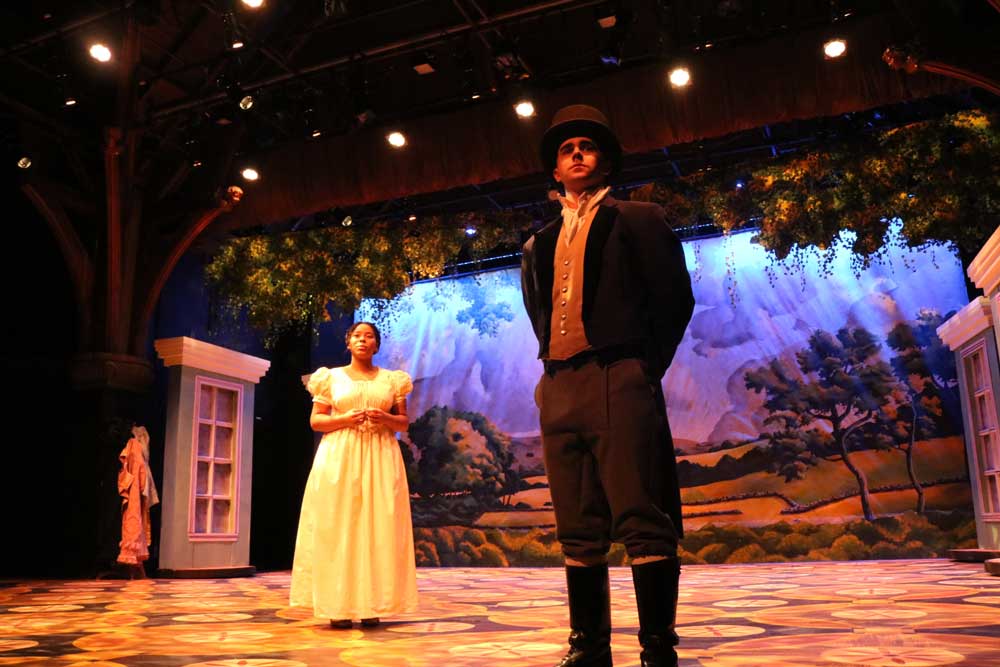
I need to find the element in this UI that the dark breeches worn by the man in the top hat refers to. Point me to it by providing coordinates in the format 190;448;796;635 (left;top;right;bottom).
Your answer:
536;358;678;558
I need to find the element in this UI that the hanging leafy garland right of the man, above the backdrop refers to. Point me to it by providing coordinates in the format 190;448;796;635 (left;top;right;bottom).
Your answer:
644;111;1000;264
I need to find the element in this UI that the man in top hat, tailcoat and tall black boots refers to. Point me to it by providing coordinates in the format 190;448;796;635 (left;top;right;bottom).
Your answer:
521;105;694;667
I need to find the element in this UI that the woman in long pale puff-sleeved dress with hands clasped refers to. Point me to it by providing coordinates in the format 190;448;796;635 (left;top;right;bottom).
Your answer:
291;322;417;628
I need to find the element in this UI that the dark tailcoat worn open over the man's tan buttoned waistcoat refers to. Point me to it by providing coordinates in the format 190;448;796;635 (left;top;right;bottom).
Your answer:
521;197;694;379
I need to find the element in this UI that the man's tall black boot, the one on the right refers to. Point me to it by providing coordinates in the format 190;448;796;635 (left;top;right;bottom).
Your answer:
632;558;681;667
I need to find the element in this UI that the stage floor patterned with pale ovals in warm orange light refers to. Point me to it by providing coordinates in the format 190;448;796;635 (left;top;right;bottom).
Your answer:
0;560;1000;667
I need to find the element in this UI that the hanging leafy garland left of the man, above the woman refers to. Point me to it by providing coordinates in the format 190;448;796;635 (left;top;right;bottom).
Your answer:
206;212;532;343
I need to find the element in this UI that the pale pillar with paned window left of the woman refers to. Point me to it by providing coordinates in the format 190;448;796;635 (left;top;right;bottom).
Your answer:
154;336;271;577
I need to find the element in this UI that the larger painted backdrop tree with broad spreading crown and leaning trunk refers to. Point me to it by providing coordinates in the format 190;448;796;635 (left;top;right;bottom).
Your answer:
744;327;896;521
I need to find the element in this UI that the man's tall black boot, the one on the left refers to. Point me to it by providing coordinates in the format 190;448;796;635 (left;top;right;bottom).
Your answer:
556;565;611;667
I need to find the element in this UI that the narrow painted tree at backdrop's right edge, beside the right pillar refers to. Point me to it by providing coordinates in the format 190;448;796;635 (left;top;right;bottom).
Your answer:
883;310;961;513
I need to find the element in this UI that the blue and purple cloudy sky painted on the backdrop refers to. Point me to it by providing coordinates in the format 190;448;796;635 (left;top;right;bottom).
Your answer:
358;226;968;442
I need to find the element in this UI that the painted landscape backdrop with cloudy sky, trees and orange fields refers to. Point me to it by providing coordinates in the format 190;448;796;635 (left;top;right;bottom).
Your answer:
358;223;975;565
